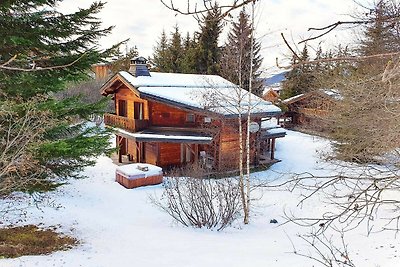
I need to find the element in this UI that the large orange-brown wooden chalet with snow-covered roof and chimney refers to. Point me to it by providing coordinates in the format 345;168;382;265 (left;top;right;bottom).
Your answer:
101;57;285;170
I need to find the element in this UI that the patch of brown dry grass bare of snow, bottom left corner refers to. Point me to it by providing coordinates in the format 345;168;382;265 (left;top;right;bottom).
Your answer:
0;225;78;258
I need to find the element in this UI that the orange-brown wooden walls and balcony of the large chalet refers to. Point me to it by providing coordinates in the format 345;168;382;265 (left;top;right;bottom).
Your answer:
105;81;268;170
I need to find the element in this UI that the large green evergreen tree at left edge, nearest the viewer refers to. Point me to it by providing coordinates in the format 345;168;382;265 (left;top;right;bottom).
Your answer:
0;0;116;194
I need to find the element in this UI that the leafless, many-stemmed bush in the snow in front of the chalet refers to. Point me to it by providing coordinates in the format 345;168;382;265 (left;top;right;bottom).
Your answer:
153;165;240;231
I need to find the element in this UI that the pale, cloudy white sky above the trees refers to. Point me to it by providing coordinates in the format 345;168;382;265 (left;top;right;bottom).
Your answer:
59;0;367;76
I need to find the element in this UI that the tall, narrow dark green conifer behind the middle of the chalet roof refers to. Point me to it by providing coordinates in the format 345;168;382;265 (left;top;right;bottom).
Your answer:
196;5;222;74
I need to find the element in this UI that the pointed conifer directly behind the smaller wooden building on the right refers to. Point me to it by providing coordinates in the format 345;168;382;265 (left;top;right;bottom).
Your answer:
281;45;317;99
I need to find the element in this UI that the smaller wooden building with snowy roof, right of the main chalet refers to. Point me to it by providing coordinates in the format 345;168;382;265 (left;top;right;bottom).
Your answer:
282;89;340;131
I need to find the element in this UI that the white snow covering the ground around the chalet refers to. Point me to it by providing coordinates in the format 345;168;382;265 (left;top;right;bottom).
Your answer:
0;131;400;267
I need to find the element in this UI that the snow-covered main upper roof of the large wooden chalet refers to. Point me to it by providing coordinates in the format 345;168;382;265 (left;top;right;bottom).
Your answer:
109;71;281;116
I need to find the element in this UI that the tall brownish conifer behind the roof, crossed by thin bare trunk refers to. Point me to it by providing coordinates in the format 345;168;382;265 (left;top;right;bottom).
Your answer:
220;10;263;96
